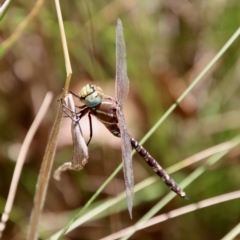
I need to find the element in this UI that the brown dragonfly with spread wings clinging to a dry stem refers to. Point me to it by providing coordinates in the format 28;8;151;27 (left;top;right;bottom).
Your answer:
68;19;187;218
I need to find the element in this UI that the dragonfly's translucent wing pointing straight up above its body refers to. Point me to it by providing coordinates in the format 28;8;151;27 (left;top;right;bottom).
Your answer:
115;19;129;106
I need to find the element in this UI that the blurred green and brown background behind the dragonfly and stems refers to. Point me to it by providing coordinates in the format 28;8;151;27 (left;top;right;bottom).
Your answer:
0;0;240;240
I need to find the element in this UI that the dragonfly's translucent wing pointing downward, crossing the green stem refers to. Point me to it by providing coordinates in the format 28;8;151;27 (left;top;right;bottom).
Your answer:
117;108;134;218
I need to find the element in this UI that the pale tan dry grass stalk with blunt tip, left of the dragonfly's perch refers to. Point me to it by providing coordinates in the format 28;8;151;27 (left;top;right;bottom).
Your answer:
0;92;53;238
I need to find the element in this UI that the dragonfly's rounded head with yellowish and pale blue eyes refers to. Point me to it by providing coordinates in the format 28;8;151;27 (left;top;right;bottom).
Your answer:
79;84;104;107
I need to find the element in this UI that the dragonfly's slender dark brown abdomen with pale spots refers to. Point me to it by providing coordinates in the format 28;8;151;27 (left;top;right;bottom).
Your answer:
130;137;187;198
